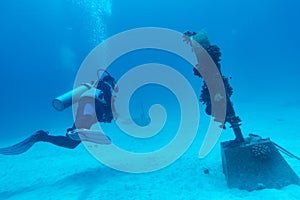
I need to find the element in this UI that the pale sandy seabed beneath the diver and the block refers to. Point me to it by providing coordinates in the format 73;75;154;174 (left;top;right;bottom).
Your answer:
0;101;300;200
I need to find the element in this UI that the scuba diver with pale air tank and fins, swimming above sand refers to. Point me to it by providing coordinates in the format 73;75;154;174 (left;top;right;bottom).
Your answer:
0;69;118;155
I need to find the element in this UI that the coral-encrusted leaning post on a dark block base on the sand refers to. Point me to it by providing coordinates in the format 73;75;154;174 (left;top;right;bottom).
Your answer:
184;31;300;191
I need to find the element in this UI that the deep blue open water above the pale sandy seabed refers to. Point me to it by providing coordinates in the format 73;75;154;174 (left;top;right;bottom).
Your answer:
0;0;300;141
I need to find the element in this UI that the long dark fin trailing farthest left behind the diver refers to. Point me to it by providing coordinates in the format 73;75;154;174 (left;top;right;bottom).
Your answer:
0;130;49;155
